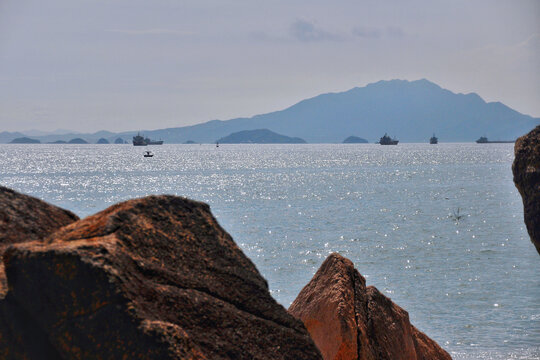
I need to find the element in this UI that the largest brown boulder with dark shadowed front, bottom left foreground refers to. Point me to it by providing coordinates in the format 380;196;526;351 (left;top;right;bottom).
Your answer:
0;196;321;359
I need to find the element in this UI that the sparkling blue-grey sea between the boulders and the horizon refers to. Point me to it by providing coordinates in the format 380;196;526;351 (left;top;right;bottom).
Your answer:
0;143;540;359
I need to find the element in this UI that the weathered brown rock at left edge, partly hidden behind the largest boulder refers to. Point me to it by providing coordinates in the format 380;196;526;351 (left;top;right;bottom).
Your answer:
0;186;79;298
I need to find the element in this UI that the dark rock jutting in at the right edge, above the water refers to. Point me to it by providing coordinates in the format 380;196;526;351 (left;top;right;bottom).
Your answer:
512;126;540;254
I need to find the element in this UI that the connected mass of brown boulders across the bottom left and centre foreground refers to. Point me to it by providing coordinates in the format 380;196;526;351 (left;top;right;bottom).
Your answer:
0;188;450;360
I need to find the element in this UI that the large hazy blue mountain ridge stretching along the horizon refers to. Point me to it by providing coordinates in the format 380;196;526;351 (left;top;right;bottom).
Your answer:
4;79;540;144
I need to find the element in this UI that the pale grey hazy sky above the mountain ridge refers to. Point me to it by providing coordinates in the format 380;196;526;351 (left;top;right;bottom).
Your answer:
0;0;540;132
